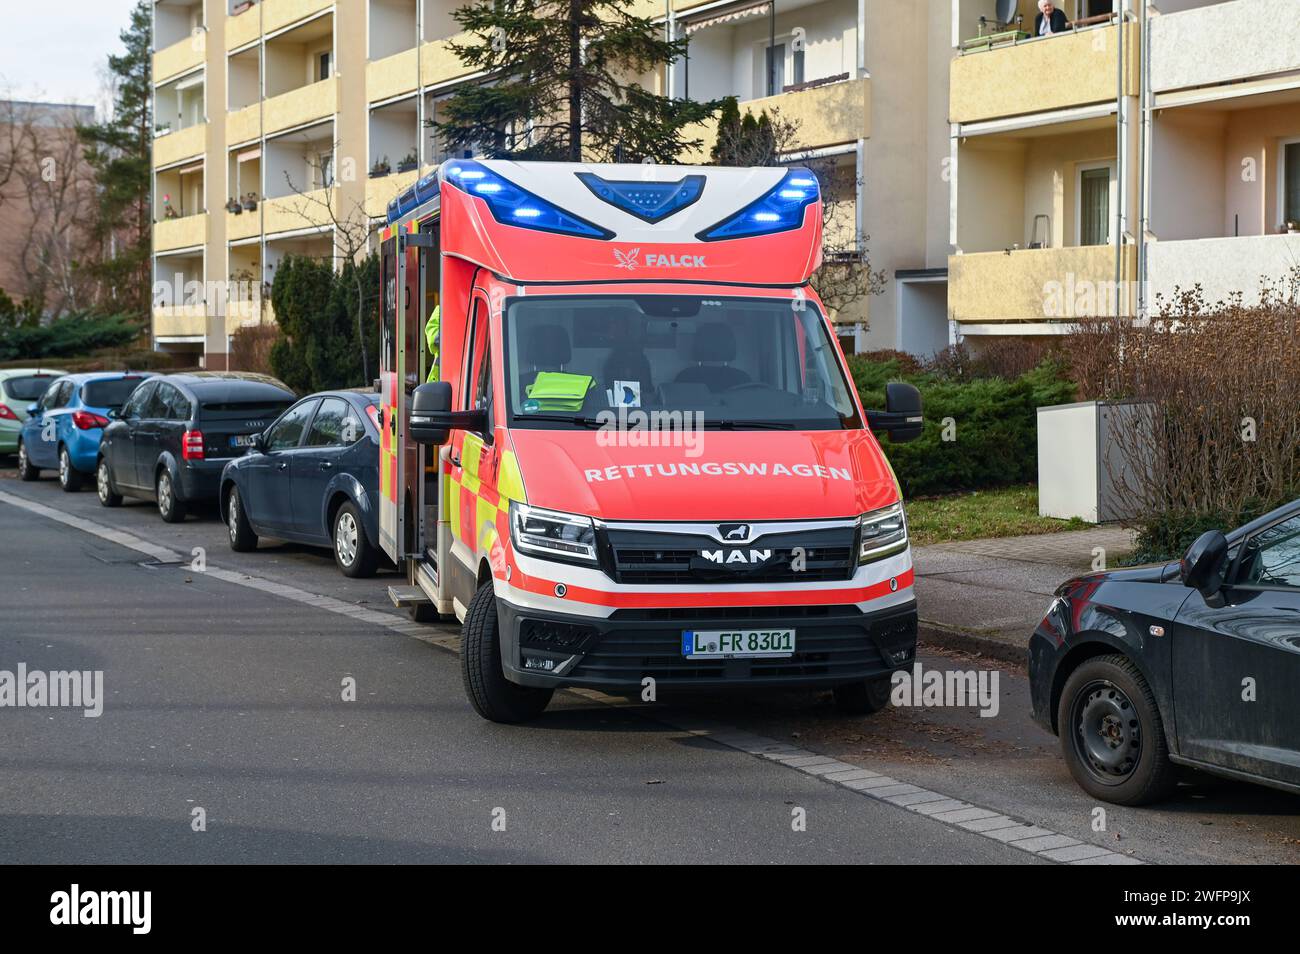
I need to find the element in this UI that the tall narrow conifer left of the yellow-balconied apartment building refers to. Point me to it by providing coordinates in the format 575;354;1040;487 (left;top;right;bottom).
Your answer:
77;0;153;316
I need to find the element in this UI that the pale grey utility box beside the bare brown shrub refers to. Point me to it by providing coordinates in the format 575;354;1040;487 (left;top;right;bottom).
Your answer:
1037;400;1152;524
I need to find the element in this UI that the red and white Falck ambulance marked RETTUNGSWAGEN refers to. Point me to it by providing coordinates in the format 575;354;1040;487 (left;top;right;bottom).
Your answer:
380;159;922;723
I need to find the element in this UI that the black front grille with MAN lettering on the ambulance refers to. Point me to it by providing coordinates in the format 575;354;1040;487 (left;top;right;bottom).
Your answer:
606;526;855;585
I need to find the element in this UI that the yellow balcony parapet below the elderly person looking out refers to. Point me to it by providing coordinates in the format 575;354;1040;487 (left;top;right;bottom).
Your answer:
948;23;1138;122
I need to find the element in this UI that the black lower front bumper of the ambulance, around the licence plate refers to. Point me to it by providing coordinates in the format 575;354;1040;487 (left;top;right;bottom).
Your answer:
497;597;917;691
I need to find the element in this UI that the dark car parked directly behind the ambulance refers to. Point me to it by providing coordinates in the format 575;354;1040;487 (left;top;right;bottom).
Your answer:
220;391;380;577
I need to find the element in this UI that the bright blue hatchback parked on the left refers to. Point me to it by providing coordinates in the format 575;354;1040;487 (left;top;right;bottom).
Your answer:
18;372;153;493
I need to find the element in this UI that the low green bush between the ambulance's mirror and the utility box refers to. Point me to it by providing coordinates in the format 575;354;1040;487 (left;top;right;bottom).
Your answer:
849;355;1074;496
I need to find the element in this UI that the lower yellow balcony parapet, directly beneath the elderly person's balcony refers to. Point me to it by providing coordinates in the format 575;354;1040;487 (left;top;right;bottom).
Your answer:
948;246;1138;324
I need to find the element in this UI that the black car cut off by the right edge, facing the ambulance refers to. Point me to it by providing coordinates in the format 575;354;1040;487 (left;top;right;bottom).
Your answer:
1030;500;1300;805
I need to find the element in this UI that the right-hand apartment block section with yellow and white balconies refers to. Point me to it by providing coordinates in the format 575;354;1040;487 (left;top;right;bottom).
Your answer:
949;0;1300;346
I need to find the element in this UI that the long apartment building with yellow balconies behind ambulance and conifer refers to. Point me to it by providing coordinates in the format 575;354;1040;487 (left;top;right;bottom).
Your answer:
153;0;952;368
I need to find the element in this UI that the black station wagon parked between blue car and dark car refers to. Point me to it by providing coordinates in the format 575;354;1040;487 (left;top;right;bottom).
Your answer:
95;372;295;524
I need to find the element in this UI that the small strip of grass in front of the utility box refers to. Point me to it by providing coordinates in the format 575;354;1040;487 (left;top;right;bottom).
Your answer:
905;483;1091;546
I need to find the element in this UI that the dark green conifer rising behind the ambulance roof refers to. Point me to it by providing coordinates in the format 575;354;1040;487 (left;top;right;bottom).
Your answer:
430;0;720;162
